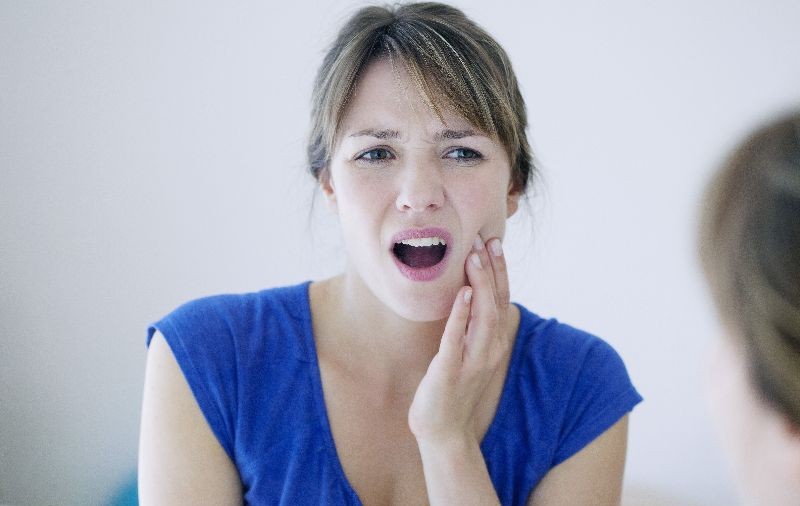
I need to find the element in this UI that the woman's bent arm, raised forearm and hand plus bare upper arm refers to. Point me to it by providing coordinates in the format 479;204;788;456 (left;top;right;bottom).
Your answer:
409;235;628;506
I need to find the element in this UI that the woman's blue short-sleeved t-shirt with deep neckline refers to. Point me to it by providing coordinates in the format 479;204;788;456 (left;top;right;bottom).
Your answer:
147;281;642;506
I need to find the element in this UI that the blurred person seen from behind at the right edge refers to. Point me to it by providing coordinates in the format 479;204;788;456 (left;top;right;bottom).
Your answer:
700;113;800;506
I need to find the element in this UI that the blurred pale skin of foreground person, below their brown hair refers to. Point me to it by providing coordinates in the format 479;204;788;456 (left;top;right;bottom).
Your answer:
707;332;800;506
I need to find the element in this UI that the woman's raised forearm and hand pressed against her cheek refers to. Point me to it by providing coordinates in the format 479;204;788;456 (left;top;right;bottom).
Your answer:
408;237;513;506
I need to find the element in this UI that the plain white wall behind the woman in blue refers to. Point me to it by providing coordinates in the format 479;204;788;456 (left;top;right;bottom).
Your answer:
0;0;800;506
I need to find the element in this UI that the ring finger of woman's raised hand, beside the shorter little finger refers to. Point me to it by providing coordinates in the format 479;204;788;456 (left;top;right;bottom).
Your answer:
464;246;497;360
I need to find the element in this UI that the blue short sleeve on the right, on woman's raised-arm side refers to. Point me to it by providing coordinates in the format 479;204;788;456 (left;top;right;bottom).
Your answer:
552;337;642;466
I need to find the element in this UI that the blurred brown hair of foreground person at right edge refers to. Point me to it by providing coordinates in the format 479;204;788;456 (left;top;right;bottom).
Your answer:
700;113;800;427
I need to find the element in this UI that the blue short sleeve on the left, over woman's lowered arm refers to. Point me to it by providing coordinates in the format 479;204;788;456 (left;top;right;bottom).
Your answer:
147;296;237;460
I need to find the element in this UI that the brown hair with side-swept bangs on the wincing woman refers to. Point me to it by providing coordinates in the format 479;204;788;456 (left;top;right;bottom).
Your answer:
307;2;534;193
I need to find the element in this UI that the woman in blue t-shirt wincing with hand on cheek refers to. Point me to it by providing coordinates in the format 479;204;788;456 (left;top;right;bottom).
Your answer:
139;3;641;506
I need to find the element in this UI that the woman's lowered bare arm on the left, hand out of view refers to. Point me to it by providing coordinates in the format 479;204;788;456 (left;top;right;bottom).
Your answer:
139;332;242;506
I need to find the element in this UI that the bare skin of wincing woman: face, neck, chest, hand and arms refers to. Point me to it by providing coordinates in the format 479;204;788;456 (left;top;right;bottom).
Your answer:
140;57;627;506
